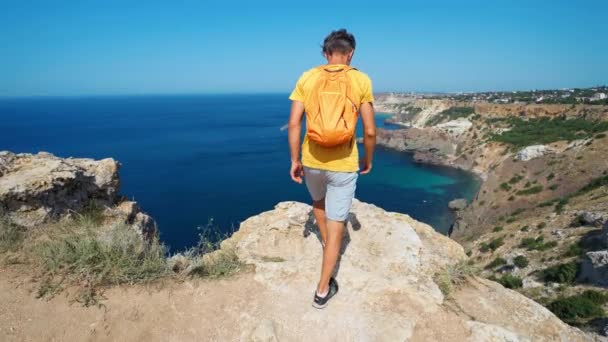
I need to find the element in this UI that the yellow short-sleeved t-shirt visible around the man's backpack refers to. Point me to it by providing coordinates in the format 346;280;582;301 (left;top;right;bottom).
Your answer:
289;64;374;172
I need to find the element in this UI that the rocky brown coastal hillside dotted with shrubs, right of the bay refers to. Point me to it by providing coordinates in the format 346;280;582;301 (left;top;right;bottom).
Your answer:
378;98;608;334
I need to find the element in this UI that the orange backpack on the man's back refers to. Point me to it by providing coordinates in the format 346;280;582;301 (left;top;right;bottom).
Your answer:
304;65;359;147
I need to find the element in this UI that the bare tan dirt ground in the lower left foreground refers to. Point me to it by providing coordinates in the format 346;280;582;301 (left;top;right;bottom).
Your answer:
0;270;264;341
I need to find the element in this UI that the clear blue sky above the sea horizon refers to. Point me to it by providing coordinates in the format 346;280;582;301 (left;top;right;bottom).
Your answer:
0;0;608;96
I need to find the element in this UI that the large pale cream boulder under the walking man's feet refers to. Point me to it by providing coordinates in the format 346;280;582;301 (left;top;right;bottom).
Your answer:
215;200;588;341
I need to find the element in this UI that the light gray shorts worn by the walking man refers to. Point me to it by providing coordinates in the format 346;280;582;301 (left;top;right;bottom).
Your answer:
304;167;359;221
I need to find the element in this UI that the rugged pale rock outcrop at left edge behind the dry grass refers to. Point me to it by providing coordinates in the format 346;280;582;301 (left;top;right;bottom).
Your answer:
0;151;156;236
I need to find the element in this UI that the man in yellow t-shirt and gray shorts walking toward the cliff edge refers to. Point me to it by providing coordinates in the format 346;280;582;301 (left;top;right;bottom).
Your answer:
289;29;376;308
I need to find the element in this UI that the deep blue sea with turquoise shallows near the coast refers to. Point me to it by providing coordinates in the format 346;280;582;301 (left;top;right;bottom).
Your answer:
0;94;480;252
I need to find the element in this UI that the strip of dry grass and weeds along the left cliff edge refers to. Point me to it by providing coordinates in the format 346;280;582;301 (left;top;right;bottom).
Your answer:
0;210;242;306
